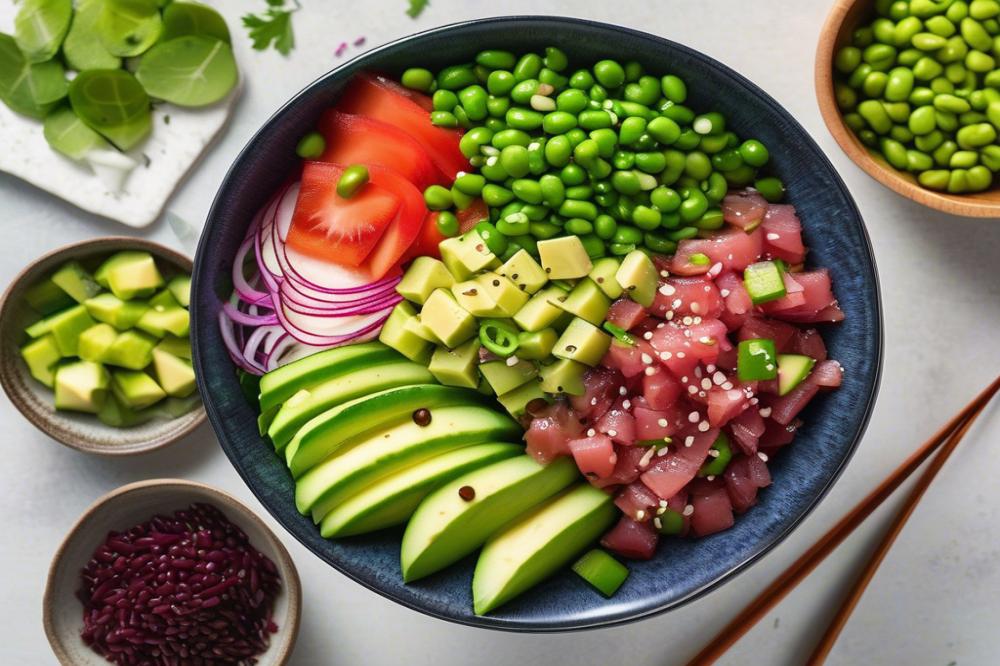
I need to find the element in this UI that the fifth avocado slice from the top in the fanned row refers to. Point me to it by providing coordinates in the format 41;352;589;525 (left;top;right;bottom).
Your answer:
320;444;524;538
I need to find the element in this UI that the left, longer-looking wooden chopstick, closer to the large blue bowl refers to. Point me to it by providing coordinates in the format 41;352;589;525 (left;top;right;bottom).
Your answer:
688;377;1000;666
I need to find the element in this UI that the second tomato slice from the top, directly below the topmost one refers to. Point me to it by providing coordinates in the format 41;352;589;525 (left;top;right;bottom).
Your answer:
319;109;449;190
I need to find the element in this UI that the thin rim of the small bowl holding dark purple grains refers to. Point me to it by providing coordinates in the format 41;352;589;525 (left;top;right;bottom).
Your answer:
42;478;302;666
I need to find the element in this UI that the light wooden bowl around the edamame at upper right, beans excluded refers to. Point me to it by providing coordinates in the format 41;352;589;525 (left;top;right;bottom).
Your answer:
816;0;1000;217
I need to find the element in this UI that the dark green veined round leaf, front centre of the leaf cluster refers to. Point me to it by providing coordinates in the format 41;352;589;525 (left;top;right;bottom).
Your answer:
69;69;152;150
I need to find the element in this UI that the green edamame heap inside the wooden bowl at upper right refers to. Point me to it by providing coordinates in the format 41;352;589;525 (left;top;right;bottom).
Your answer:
834;0;1000;194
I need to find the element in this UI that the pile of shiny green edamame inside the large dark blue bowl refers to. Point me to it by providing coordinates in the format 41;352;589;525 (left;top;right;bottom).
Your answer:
402;47;784;258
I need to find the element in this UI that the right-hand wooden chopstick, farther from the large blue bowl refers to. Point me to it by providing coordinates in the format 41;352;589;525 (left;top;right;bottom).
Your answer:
807;396;986;665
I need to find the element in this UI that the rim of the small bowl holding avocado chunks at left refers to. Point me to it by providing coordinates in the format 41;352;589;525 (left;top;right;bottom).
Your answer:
0;236;208;458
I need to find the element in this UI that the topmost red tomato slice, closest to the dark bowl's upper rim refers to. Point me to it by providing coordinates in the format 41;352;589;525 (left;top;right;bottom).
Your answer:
337;74;471;180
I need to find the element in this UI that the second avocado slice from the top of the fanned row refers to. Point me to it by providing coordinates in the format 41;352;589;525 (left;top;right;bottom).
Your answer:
267;361;435;451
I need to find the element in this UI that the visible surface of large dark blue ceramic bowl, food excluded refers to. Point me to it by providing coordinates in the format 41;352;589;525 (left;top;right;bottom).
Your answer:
192;17;882;631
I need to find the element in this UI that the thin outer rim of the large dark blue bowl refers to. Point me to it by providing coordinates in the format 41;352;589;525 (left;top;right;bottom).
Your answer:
191;14;884;634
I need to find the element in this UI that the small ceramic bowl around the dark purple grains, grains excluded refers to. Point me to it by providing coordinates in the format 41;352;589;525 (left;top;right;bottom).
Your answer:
42;479;302;666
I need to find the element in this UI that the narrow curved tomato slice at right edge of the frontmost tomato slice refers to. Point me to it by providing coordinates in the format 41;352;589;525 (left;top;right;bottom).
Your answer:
366;166;427;280
